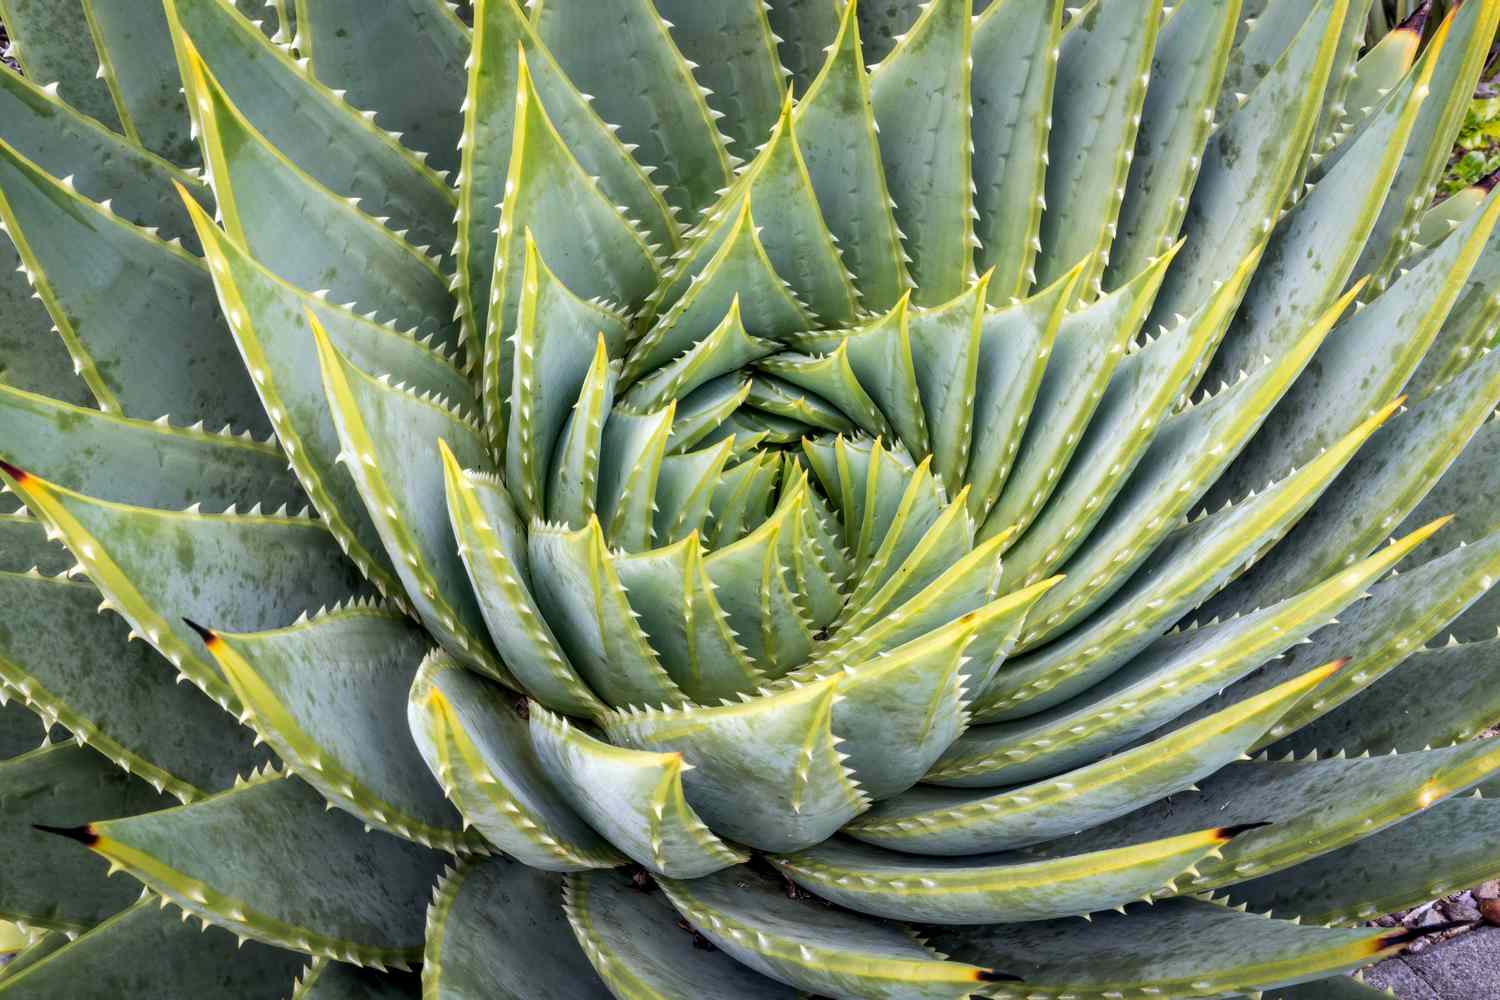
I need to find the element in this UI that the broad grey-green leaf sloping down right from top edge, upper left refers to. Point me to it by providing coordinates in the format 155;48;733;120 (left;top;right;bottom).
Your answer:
164;0;453;254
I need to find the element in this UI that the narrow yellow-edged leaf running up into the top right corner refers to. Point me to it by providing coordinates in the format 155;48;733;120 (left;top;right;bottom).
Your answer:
1350;6;1500;292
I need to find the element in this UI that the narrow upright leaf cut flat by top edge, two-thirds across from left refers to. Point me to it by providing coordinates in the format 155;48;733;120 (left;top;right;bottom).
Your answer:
969;0;1073;303
